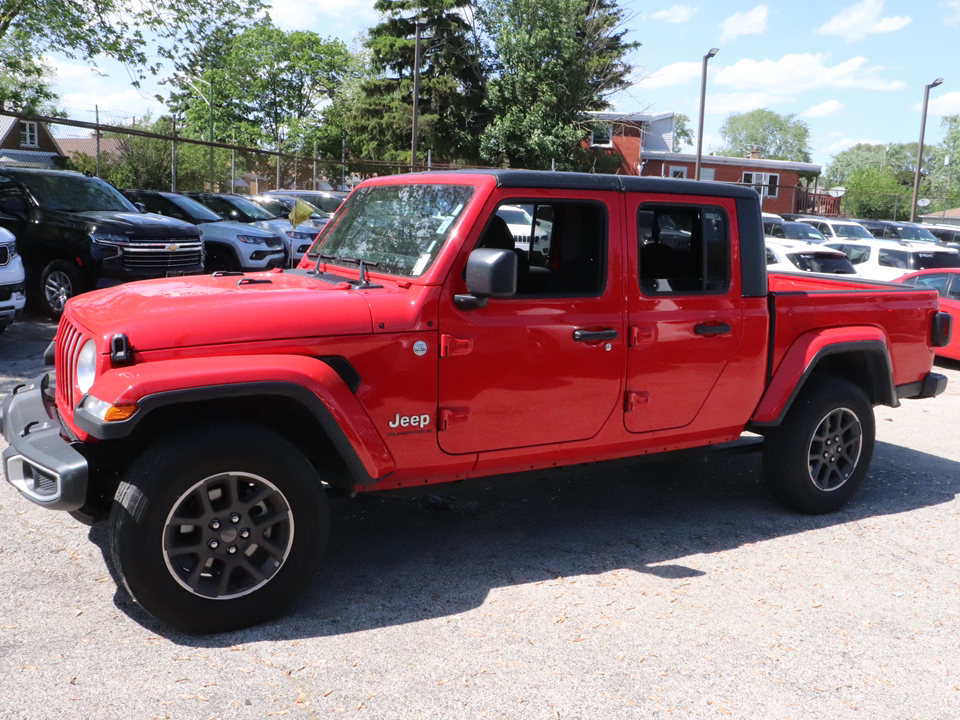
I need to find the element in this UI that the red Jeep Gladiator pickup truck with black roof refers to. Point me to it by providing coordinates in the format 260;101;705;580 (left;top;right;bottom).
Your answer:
2;170;950;632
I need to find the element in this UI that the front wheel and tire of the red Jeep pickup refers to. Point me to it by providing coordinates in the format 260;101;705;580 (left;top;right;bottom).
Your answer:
110;423;329;633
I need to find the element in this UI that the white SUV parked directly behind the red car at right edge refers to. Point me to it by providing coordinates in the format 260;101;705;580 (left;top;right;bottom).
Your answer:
826;238;960;280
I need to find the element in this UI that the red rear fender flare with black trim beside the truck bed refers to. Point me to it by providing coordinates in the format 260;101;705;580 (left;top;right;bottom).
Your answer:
750;326;899;428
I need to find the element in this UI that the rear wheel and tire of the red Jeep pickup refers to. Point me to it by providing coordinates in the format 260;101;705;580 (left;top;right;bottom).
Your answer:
763;377;876;515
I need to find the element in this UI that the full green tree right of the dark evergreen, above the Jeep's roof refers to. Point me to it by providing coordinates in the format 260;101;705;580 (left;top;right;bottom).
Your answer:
478;0;639;169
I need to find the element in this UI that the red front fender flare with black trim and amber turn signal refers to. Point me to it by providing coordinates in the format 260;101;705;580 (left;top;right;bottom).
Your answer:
74;355;396;484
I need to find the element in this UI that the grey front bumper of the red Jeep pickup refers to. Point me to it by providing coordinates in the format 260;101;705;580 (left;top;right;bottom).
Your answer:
0;374;88;511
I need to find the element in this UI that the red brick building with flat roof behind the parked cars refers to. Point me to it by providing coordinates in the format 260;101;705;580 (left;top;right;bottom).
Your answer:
589;112;822;213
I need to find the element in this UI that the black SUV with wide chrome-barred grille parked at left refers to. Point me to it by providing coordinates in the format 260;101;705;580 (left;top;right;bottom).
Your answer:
0;168;203;317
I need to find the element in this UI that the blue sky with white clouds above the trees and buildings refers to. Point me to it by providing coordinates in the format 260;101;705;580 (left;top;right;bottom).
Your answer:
50;0;960;169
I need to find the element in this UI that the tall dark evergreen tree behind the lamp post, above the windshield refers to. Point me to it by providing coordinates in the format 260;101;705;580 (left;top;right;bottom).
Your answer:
351;0;487;162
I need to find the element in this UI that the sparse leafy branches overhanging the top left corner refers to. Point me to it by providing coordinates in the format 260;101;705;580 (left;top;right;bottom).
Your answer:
0;0;265;86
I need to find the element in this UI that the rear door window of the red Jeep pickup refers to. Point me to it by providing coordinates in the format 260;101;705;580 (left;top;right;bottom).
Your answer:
637;204;730;295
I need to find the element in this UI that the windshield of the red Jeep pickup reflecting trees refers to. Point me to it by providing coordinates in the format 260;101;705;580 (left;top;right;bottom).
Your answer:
309;185;474;277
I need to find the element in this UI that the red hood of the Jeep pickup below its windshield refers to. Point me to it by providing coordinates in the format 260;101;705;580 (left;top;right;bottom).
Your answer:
67;271;373;352
